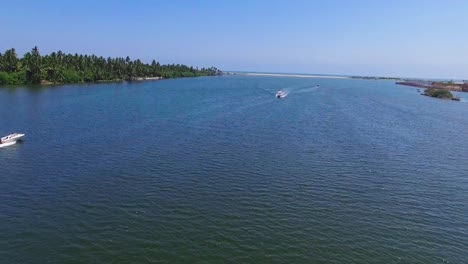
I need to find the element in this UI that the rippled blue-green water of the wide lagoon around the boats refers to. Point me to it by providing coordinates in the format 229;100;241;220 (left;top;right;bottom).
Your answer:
0;76;468;263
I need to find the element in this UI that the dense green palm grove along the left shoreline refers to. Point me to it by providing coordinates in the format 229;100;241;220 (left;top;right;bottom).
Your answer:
0;47;222;85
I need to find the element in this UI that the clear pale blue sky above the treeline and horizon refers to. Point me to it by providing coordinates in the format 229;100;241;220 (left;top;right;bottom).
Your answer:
0;0;468;79
